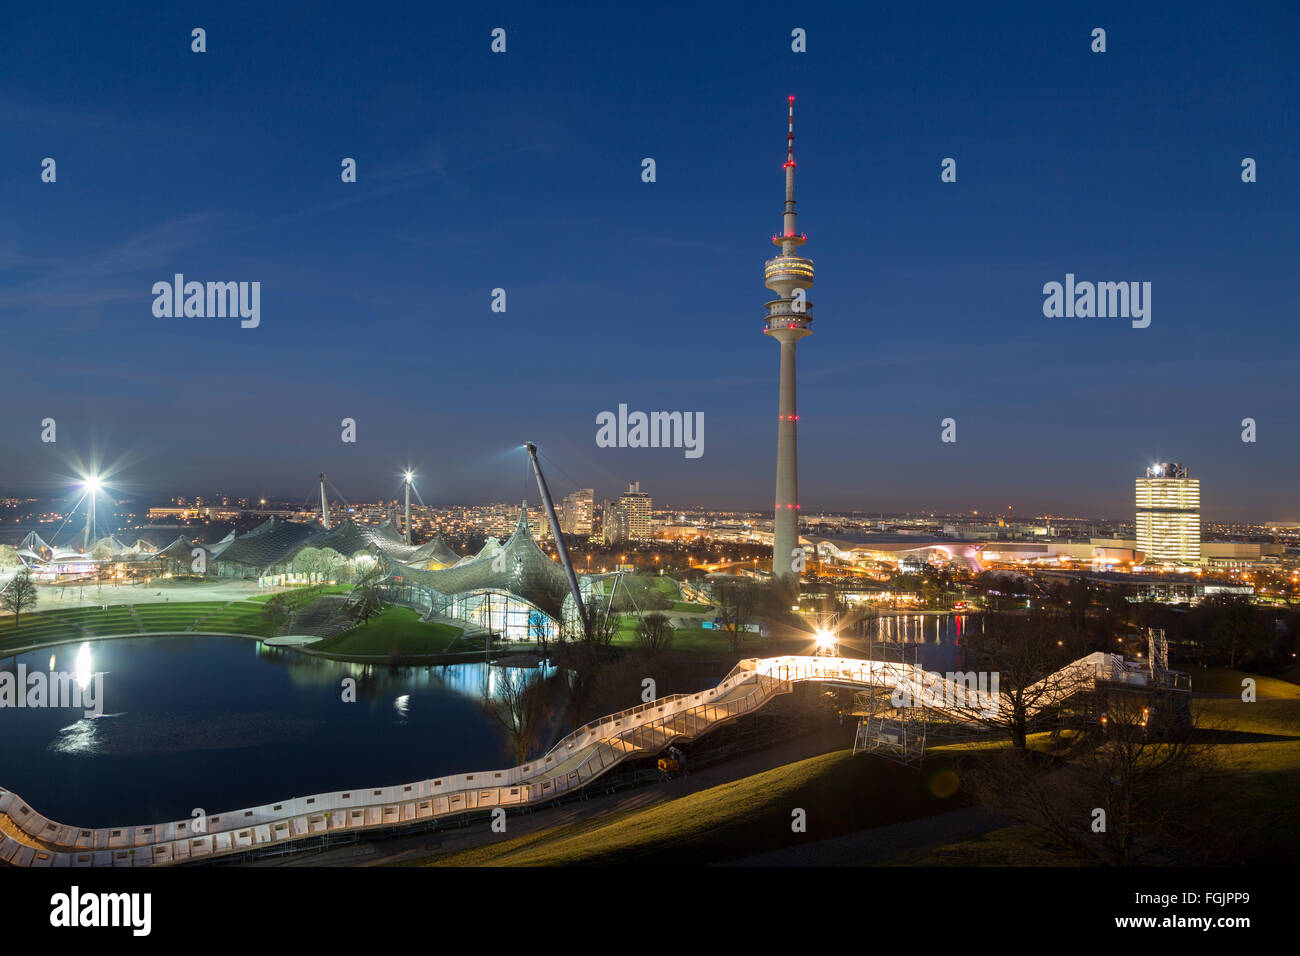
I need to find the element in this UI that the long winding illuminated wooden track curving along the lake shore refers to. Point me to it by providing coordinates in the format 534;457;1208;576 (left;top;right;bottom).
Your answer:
0;653;1145;866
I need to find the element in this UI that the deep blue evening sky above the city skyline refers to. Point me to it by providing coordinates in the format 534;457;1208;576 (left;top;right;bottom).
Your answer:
0;3;1300;519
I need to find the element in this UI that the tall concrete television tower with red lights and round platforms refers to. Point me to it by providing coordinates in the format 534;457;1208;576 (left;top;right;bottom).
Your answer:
763;96;813;578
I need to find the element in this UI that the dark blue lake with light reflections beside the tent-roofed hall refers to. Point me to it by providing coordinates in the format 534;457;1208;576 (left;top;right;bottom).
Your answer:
0;636;567;826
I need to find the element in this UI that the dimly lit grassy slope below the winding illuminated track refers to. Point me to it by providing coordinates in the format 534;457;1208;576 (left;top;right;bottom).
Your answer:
417;750;962;866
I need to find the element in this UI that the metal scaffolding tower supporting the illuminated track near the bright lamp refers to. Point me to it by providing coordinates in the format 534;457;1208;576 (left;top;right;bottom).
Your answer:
853;641;928;767
